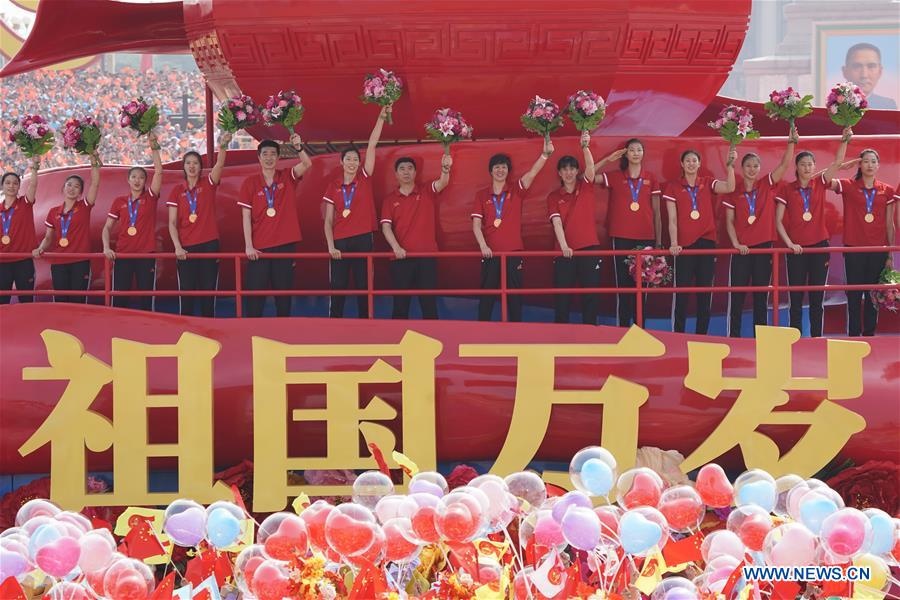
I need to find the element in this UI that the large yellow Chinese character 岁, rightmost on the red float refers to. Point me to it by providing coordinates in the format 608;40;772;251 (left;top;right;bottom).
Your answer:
681;326;870;477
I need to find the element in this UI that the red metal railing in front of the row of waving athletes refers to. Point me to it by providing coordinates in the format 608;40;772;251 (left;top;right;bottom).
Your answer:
0;246;900;325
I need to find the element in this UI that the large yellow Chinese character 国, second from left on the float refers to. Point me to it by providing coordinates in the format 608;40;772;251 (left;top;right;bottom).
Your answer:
253;331;443;512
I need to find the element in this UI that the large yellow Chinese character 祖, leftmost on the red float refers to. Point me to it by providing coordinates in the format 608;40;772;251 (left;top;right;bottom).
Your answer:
19;329;231;510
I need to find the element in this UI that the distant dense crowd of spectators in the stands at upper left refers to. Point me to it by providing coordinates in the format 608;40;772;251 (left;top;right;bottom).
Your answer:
0;67;240;172
